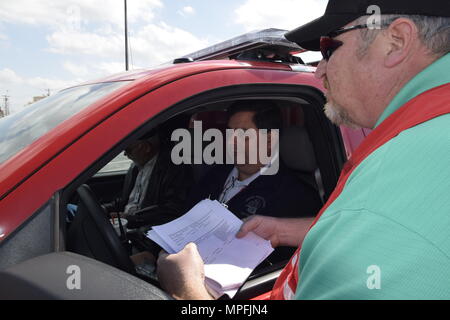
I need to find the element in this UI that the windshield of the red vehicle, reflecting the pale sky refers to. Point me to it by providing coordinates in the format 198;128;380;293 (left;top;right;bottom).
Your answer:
0;81;129;164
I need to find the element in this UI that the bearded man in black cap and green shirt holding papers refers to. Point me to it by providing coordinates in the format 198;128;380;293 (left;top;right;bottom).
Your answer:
159;0;450;299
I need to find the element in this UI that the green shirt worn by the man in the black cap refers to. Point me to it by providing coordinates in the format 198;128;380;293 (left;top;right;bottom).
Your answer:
295;54;450;299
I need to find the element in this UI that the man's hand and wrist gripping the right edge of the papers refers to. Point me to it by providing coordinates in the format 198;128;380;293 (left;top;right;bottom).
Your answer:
236;216;314;248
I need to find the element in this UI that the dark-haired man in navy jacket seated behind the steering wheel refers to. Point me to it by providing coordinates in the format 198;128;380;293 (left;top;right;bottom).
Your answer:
187;100;322;219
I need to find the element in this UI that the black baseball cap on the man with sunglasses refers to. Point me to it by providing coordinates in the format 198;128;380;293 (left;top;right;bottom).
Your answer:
285;0;450;51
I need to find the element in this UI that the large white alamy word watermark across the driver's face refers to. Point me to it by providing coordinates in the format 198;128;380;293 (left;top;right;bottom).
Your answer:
171;121;280;175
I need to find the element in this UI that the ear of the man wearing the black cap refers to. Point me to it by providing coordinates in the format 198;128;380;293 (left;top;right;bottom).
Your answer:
384;18;418;68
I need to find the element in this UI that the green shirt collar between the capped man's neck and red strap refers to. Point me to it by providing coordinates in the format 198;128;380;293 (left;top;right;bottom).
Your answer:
375;53;450;128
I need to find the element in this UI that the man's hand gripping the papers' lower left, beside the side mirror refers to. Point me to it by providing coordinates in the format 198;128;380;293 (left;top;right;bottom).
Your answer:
157;243;212;300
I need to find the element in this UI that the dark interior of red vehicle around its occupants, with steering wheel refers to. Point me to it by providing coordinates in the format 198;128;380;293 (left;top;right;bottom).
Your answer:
60;90;343;299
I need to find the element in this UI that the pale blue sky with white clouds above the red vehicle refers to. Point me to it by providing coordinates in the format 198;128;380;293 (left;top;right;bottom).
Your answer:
0;0;327;112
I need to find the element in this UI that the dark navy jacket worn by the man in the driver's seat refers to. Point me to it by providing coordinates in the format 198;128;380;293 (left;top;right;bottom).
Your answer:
187;164;322;219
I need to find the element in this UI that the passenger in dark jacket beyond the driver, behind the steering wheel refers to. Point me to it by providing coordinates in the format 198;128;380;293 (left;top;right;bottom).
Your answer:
104;134;192;229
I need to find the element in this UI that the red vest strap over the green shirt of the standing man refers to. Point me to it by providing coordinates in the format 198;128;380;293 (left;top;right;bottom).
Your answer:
271;83;450;300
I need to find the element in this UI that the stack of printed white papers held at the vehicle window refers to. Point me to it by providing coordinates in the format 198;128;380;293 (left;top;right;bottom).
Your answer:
147;200;273;298
